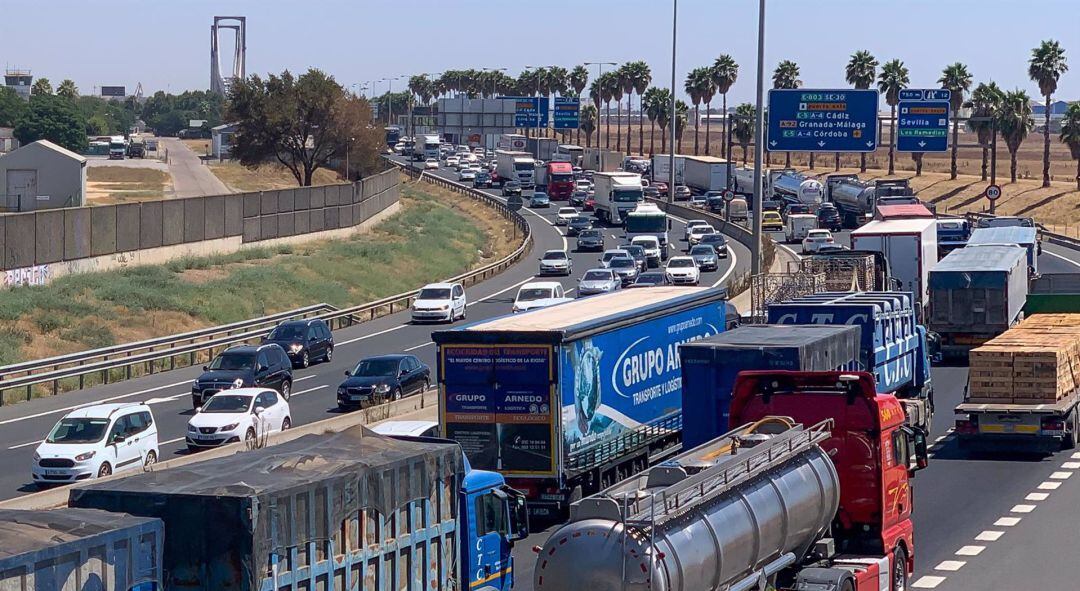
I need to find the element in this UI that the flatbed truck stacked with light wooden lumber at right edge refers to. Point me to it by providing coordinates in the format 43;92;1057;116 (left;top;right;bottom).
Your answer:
956;314;1080;452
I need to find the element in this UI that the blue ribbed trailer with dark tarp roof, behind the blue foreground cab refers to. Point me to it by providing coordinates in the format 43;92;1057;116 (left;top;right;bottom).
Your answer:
69;427;470;591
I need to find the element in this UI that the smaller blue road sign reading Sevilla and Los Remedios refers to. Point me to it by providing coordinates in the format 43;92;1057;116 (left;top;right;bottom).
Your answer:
896;89;950;152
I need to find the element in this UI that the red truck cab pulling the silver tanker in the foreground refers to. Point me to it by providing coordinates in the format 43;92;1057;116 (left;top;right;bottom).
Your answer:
730;371;927;591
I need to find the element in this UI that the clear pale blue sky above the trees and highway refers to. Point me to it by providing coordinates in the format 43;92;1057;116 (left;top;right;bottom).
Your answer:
0;0;1080;103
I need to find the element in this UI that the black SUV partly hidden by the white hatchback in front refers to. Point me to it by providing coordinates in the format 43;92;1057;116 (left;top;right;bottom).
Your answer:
191;342;293;408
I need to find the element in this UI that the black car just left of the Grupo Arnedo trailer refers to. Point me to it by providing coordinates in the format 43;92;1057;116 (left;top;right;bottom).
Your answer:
337;354;431;411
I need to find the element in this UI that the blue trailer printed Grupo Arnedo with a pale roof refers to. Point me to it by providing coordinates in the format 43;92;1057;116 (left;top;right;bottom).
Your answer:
432;287;732;516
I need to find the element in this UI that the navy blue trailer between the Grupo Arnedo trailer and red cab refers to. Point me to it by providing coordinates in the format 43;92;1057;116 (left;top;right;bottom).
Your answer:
679;324;862;448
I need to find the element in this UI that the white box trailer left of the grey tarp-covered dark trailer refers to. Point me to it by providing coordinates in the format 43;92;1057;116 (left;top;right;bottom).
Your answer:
851;218;937;322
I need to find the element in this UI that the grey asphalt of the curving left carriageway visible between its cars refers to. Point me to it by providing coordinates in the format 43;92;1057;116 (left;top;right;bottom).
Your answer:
0;160;750;499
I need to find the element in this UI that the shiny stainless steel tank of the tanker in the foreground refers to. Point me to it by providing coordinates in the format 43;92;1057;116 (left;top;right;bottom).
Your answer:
534;417;840;591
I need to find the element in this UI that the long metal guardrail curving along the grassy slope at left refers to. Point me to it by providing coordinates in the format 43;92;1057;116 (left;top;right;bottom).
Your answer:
0;163;532;405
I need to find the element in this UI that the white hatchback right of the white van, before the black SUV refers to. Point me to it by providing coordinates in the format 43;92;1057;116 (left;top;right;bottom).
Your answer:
185;388;293;452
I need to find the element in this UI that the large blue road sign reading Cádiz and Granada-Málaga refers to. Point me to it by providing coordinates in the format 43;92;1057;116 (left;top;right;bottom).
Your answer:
766;89;878;152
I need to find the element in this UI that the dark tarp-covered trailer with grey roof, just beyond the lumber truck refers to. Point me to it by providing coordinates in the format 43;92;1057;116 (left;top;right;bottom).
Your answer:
928;245;1027;354
